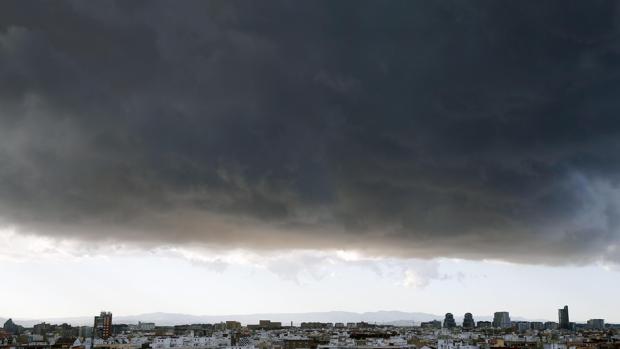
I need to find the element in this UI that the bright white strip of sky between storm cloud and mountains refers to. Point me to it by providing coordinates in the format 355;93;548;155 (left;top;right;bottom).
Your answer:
0;230;620;322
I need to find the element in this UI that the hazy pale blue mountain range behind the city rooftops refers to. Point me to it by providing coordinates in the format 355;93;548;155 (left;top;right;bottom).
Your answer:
0;311;546;327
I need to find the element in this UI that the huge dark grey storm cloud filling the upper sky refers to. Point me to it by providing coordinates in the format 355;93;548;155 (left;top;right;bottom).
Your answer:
0;1;620;263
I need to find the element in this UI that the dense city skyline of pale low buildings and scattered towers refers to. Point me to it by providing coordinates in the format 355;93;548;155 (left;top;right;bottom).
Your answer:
0;305;620;349
